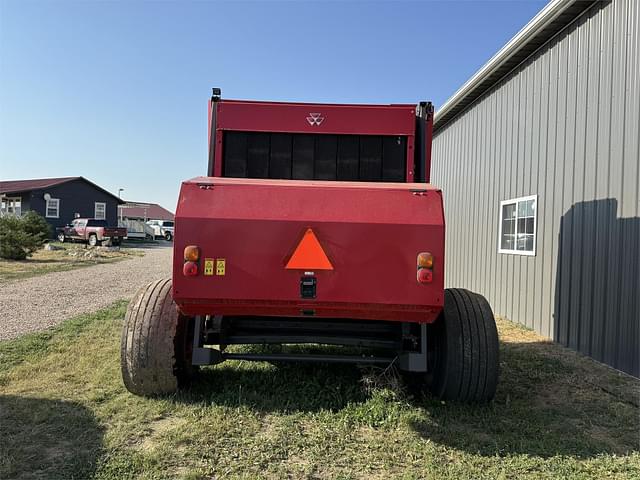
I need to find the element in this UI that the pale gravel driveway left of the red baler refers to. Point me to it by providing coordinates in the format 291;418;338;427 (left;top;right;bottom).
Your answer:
0;246;173;340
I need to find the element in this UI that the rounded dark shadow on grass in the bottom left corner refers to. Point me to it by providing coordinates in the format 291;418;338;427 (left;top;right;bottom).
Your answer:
0;395;103;480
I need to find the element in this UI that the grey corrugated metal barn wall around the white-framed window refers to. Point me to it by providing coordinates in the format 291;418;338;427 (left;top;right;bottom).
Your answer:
432;0;640;376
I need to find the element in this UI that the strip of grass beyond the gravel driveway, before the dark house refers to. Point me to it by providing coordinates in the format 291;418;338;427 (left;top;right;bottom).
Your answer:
0;242;144;284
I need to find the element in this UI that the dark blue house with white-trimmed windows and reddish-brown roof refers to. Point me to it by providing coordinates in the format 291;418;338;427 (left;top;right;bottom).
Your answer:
0;177;124;231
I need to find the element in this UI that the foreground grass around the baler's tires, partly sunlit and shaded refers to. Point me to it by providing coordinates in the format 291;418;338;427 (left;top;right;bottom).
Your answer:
0;303;640;479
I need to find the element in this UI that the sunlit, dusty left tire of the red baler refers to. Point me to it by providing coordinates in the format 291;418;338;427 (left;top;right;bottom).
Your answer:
120;279;195;396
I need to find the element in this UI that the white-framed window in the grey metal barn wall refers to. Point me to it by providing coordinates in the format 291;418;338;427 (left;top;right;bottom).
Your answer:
498;195;538;255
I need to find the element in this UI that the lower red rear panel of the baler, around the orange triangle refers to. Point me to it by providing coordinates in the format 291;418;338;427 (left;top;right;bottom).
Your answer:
173;177;444;322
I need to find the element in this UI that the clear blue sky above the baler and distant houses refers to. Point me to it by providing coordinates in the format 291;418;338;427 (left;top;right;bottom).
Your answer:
0;0;546;211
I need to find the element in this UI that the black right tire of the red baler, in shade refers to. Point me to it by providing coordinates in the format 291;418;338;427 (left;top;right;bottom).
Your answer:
427;288;499;403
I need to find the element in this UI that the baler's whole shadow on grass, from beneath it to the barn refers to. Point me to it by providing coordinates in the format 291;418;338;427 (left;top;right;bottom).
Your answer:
178;331;640;458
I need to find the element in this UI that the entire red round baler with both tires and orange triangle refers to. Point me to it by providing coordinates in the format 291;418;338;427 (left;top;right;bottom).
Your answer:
121;89;498;402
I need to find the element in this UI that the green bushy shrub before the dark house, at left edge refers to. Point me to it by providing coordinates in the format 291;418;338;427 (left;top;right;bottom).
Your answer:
0;211;51;260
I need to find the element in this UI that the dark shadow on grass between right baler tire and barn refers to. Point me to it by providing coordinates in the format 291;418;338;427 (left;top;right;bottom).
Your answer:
411;341;640;459
